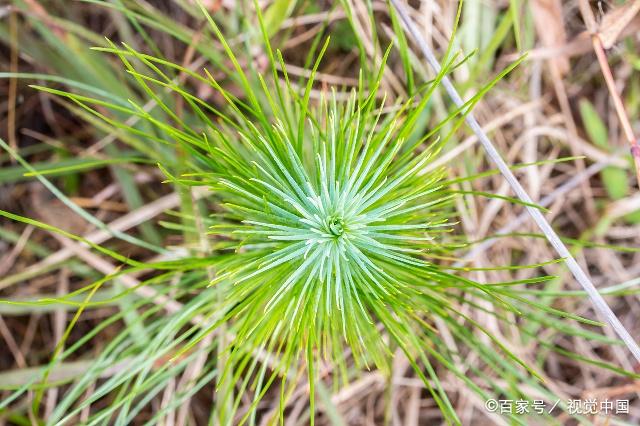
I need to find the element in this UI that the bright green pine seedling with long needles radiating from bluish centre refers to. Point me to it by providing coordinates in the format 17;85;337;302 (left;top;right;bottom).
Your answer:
41;34;528;422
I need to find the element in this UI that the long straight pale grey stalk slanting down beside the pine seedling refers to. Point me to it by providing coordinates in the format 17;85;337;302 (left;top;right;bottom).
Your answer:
391;0;640;363
